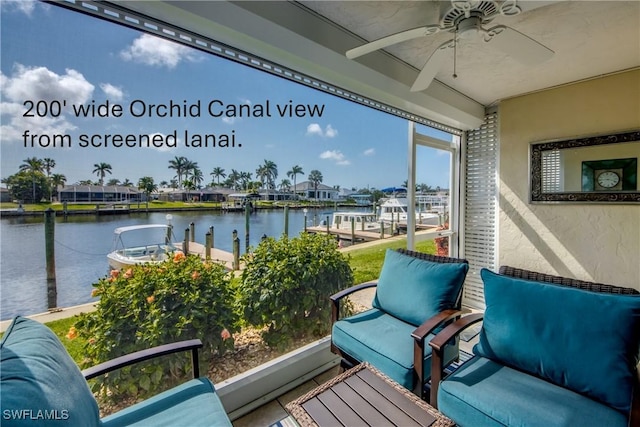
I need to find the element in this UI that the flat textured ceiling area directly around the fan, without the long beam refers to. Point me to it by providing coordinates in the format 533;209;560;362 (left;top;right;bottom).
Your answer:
302;1;640;105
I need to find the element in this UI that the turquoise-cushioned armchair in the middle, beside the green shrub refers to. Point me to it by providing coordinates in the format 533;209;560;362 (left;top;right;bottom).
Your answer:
331;249;469;395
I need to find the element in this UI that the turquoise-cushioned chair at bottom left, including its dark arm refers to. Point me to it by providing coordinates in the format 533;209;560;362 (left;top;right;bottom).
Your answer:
0;317;231;427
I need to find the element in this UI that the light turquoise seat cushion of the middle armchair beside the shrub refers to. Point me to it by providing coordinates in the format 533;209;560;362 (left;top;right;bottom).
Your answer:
331;308;458;389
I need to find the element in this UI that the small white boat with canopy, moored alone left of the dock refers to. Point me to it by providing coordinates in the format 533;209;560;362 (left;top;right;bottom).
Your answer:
107;224;178;270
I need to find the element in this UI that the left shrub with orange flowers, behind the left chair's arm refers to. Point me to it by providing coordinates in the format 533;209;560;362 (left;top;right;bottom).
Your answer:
67;252;239;397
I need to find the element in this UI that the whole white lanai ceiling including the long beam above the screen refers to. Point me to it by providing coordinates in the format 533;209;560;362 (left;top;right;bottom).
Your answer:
119;0;640;129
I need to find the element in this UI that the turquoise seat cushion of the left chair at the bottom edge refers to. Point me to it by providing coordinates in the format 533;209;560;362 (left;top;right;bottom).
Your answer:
102;378;231;427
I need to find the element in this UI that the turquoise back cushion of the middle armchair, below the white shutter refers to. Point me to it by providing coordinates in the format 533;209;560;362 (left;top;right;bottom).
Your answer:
373;249;469;326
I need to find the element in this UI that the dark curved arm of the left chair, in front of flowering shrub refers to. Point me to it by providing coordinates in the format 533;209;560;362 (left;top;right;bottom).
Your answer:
82;339;202;380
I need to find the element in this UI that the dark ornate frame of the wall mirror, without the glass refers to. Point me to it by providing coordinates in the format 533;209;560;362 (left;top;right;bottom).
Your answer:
529;130;640;204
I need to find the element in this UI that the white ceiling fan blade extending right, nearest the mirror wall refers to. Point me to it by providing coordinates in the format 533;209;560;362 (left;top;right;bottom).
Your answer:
485;25;554;65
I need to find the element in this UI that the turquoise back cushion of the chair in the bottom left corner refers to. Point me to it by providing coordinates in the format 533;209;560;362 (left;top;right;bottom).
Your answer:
0;317;100;427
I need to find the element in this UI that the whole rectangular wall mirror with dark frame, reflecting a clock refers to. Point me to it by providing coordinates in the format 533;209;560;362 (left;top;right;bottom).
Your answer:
529;130;640;204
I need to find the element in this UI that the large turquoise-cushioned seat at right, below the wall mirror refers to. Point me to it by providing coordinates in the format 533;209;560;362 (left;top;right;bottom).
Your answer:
430;266;640;427
